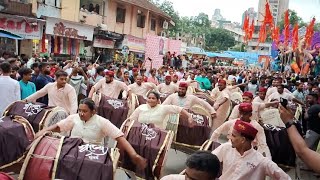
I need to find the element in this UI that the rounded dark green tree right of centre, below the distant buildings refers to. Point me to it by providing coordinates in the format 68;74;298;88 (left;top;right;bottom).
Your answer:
205;28;236;51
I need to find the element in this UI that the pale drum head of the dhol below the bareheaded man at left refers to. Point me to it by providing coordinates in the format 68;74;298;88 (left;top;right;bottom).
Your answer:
43;107;68;127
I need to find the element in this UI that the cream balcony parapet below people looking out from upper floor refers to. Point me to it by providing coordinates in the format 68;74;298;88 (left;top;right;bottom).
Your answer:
79;10;107;26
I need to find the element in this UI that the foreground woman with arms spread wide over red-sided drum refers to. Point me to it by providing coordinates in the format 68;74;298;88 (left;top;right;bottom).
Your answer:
35;98;146;169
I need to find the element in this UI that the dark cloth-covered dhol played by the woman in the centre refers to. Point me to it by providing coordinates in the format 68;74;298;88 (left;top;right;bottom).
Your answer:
119;120;173;180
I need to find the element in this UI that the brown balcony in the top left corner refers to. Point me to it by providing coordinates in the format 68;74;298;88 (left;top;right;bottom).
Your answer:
1;1;32;16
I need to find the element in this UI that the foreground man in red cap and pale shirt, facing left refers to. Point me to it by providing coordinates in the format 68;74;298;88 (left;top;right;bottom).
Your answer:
212;120;291;180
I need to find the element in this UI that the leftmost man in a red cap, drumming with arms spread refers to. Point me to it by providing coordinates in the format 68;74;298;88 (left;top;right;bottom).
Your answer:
88;71;131;99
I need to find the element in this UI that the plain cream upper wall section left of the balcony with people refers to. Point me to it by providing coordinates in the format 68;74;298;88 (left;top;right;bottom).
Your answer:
61;0;80;22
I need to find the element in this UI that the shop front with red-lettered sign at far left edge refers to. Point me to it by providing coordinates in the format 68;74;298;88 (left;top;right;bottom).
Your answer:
0;14;44;57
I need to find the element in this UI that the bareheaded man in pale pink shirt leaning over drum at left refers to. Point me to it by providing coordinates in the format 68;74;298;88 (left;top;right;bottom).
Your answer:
25;70;78;114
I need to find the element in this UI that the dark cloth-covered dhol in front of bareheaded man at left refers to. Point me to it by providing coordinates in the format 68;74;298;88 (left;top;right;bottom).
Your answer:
4;101;68;132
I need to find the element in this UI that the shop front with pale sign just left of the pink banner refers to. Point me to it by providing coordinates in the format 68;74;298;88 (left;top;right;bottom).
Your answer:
115;35;146;65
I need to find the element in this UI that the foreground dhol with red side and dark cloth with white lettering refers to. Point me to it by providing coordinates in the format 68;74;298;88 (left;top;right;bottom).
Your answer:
19;135;118;180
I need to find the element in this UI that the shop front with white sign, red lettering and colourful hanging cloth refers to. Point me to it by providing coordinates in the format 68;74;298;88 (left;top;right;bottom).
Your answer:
41;18;94;60
